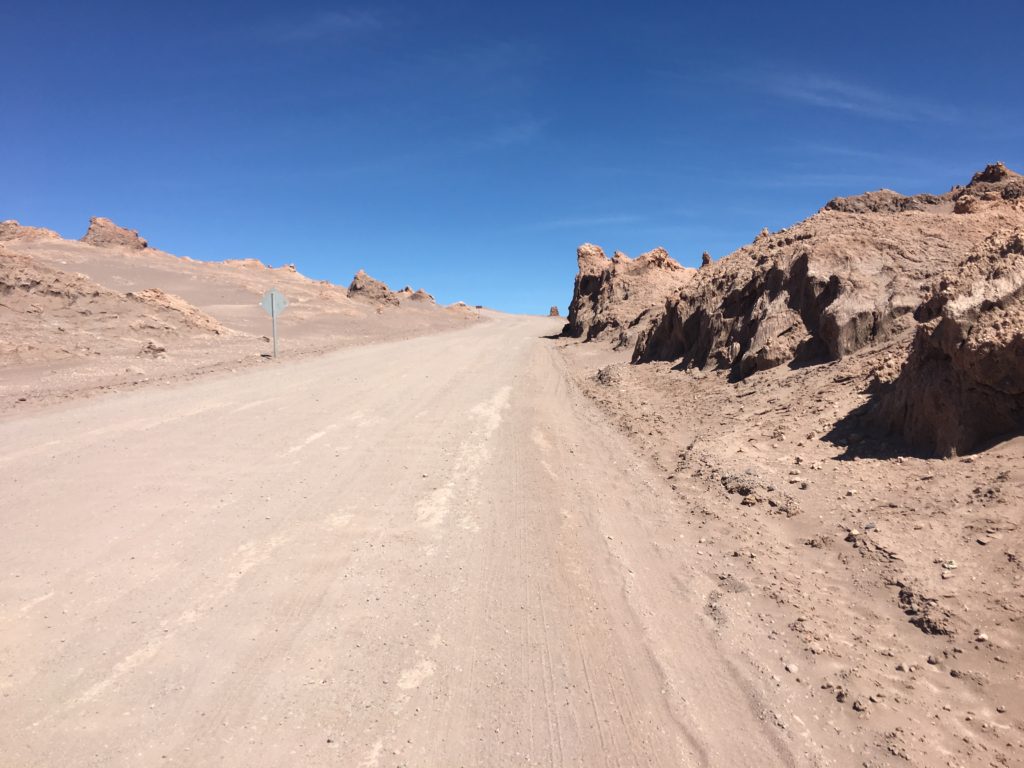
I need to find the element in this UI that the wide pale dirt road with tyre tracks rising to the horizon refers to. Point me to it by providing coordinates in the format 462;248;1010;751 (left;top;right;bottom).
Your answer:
0;316;798;767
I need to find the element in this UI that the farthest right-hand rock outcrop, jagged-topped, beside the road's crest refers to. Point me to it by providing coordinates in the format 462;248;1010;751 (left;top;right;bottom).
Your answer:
562;243;696;344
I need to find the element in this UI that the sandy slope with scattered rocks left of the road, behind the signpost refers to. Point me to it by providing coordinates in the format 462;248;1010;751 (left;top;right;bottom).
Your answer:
0;236;479;413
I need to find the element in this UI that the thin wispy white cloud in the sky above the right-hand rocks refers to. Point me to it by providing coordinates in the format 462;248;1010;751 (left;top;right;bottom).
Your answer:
753;74;959;123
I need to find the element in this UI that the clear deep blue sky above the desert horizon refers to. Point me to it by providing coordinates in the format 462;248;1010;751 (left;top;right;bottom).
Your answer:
0;0;1024;312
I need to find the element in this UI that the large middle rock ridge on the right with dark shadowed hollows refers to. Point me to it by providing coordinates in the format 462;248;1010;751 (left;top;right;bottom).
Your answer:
634;166;1024;378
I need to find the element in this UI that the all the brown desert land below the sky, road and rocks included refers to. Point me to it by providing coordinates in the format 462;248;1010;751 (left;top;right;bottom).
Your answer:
0;165;1024;768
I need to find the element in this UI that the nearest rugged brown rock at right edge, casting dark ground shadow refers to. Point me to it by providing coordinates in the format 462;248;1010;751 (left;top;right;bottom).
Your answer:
873;231;1024;456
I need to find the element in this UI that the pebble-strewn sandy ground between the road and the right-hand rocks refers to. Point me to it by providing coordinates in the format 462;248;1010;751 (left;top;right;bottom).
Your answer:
556;341;1024;768
